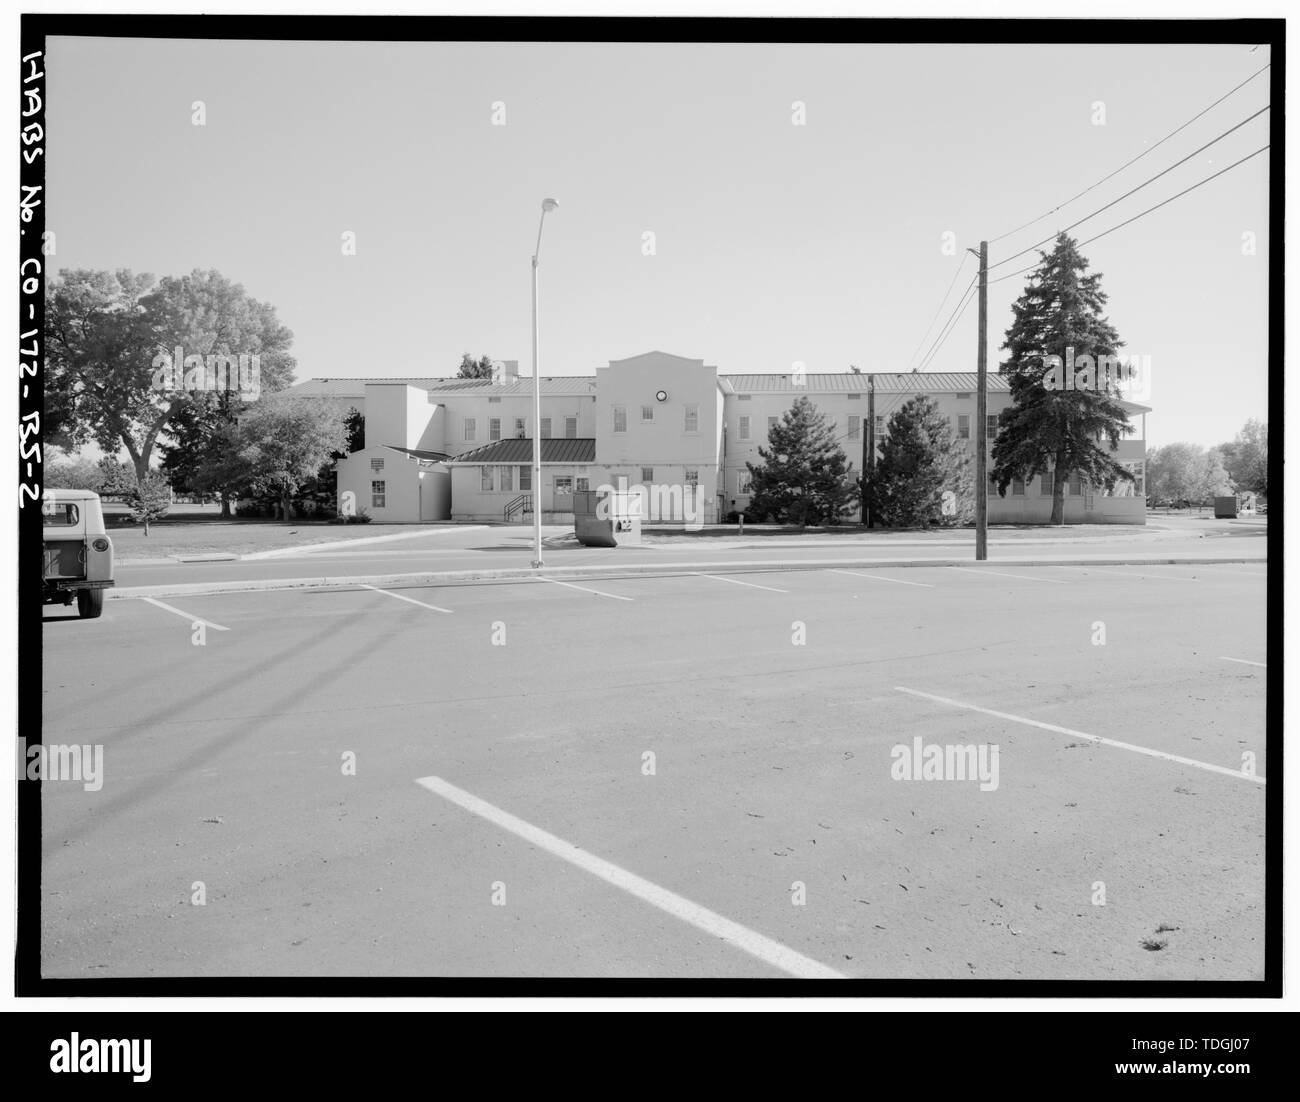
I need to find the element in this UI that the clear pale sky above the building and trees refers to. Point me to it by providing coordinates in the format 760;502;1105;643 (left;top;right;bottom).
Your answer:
47;39;1270;444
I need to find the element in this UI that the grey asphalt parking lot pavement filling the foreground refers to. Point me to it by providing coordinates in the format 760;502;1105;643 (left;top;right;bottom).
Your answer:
43;565;1269;979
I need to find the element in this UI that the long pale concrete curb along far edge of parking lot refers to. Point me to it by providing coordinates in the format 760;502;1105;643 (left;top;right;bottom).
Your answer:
108;555;1268;600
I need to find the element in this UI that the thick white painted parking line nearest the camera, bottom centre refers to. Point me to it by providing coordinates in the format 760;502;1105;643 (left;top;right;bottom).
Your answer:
416;777;846;980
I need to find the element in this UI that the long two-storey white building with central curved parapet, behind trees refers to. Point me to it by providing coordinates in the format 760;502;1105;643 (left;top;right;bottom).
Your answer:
290;352;1149;524
